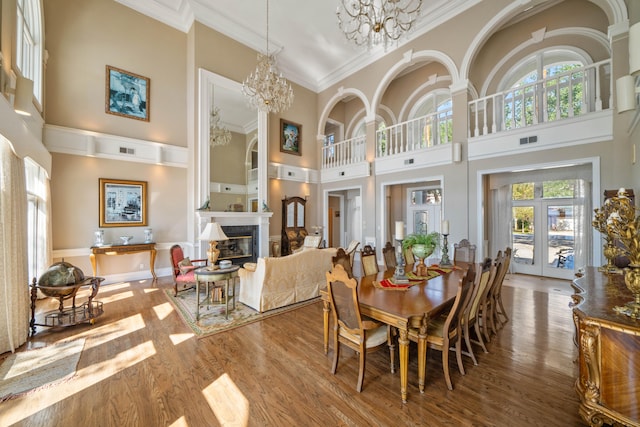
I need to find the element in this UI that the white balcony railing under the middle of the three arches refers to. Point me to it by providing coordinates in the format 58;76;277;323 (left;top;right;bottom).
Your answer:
376;108;453;157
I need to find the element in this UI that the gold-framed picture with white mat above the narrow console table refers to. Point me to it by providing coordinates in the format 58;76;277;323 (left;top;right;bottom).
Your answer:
99;178;147;227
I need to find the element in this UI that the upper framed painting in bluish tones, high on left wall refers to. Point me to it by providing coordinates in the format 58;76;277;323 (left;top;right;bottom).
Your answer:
104;65;151;122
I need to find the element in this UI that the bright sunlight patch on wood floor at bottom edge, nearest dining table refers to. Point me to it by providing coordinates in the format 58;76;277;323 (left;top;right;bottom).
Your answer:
202;374;249;427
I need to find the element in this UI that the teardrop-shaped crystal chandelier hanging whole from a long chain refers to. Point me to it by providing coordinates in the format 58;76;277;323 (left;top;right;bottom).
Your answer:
242;0;293;113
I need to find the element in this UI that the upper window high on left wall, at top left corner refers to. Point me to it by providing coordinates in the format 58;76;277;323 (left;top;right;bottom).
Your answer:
16;0;44;105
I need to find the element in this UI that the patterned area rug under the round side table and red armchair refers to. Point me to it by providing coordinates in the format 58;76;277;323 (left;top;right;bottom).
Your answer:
165;289;320;338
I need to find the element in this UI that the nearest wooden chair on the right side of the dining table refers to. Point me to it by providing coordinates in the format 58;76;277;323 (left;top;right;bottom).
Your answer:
408;275;472;391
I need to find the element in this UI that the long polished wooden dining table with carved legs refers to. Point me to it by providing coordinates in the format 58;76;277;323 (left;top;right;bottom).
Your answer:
320;262;471;403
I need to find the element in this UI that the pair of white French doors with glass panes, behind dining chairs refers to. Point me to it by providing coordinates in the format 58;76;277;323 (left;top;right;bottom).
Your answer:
511;199;575;279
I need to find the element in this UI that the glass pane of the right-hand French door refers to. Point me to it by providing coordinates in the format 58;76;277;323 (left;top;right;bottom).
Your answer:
547;206;574;270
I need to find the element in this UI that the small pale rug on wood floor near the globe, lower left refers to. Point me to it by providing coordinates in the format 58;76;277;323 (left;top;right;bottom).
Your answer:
0;338;85;402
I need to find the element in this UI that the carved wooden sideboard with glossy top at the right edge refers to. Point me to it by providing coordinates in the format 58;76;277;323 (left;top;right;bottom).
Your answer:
572;267;640;426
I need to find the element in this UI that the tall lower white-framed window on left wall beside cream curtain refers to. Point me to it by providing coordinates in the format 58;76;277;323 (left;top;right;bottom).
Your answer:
24;158;49;280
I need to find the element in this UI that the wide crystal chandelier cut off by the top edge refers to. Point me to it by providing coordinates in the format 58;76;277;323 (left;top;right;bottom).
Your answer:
336;0;422;49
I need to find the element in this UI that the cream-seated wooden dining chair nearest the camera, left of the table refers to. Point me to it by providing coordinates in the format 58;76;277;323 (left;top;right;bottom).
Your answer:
326;264;395;393
